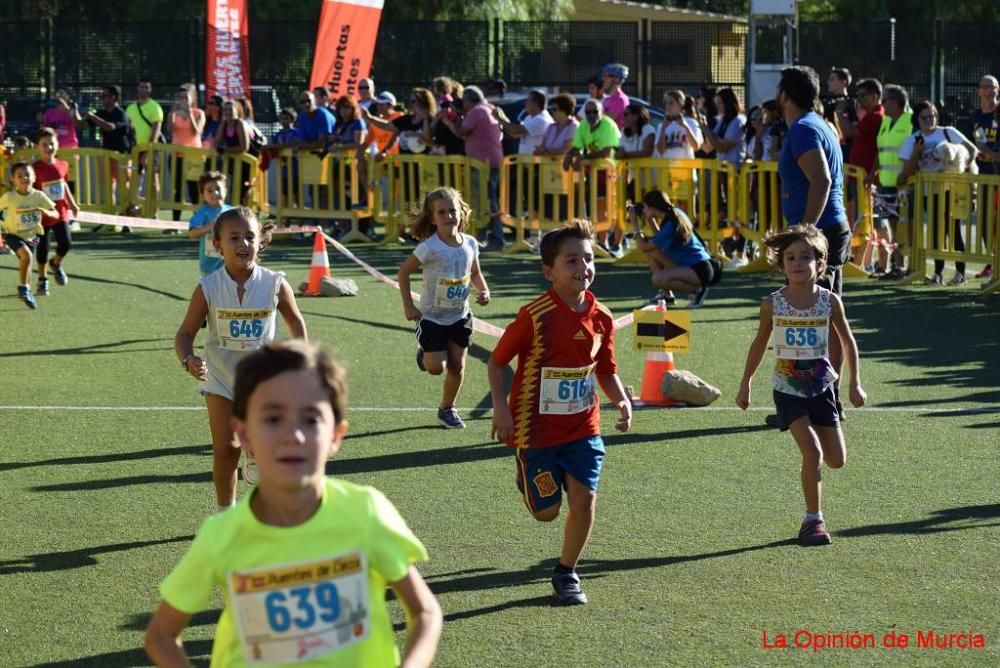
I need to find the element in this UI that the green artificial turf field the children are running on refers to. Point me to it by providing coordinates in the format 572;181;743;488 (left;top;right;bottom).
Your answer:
0;232;1000;666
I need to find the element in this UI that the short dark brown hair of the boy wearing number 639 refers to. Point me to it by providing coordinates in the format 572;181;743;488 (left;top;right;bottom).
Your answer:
233;339;347;424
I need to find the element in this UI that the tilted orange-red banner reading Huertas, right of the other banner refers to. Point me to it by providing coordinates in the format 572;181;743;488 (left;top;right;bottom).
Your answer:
309;0;385;97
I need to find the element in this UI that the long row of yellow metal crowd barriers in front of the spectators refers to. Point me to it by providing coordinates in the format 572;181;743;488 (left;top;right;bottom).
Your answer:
0;144;1000;292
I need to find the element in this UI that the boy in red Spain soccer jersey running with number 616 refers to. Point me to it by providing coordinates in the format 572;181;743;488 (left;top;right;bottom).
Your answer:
487;219;632;605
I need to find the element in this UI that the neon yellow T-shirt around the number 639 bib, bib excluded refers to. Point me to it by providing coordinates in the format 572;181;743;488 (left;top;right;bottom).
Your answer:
160;478;427;667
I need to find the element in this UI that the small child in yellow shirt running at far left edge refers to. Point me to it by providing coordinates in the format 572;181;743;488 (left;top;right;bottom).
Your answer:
0;161;59;309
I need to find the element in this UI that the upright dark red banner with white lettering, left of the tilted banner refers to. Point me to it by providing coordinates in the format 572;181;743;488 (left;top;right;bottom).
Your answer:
205;0;250;98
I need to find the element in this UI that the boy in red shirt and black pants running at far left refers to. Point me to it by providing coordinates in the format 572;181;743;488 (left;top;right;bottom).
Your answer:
32;128;80;295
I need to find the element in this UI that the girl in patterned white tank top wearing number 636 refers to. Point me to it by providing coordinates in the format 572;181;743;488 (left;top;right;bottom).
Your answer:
736;225;867;545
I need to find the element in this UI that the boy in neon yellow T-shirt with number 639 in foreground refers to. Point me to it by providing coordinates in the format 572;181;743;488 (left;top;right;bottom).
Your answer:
146;340;442;667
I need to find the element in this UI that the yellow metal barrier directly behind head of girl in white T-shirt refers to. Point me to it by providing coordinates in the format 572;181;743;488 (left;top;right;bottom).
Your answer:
385;154;490;243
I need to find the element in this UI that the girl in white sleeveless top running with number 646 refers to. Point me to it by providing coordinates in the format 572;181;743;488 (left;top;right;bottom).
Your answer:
174;206;306;508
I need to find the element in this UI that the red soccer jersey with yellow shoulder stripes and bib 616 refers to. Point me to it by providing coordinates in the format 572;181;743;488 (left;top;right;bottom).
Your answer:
493;290;618;448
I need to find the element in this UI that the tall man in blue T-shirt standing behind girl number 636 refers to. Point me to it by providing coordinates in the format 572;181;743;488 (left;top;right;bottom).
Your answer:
776;67;851;294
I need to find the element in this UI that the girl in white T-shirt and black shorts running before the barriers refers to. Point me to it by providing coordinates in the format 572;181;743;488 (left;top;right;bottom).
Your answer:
399;188;490;429
